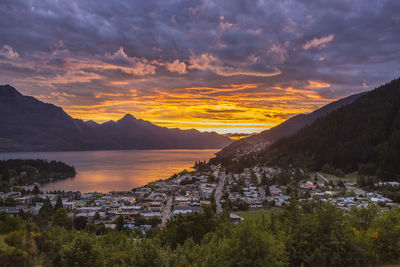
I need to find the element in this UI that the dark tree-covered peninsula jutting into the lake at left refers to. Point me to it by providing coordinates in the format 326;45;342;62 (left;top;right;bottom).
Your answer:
0;159;76;192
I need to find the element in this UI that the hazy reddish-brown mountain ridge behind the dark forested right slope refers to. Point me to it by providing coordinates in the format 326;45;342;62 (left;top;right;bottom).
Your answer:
216;92;365;158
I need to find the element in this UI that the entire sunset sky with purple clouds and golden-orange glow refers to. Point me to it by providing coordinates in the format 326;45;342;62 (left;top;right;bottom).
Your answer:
0;0;400;134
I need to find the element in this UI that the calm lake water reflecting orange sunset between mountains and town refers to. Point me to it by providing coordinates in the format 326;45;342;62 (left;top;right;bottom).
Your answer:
0;149;218;192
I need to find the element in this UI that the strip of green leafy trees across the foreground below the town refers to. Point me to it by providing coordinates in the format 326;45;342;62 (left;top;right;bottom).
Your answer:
0;197;400;267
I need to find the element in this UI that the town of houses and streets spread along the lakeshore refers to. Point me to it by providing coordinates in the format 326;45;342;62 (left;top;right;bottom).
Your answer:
0;162;400;233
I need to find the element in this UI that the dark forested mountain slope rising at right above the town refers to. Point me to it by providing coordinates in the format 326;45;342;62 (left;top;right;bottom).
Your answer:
247;79;400;179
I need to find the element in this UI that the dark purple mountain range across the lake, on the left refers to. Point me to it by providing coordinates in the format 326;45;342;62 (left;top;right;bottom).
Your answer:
0;85;231;152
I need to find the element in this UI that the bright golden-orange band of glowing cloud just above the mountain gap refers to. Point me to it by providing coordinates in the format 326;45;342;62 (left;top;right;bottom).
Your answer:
58;84;332;133
